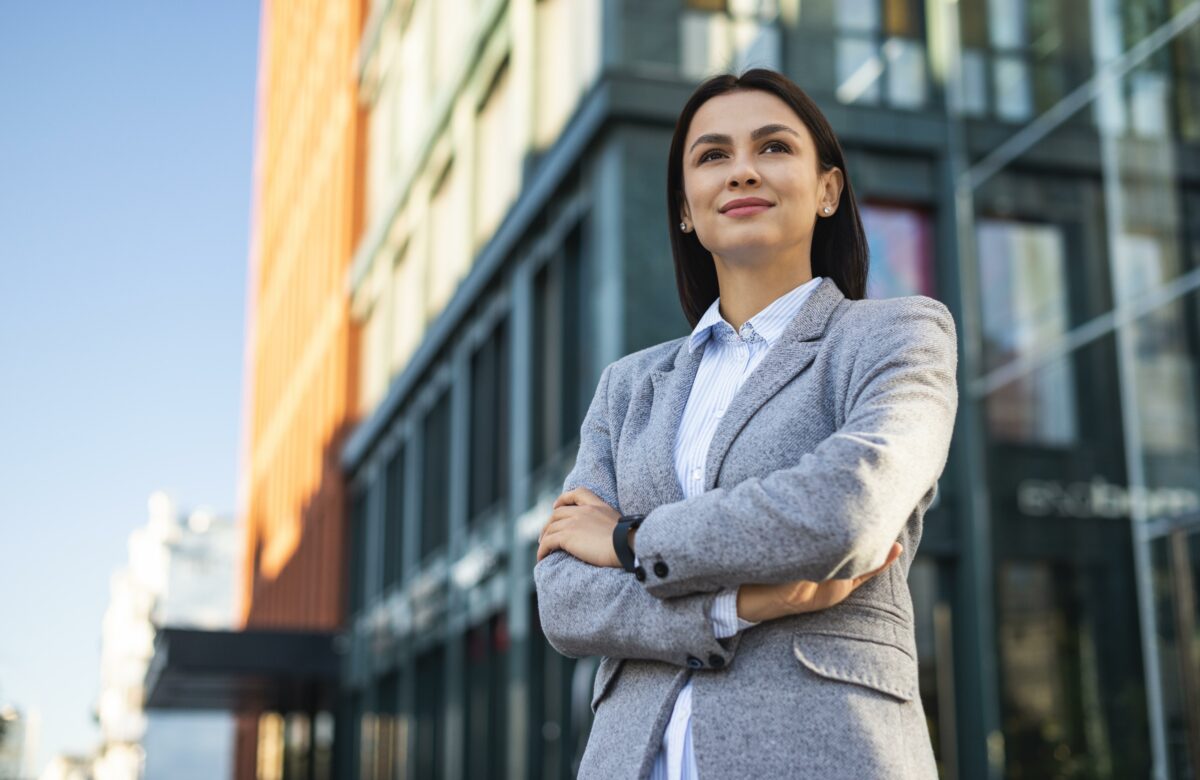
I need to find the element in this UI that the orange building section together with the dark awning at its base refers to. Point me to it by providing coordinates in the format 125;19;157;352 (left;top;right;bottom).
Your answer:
139;0;365;778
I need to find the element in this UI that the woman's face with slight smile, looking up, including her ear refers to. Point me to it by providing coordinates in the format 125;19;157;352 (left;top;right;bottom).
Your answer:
680;90;842;260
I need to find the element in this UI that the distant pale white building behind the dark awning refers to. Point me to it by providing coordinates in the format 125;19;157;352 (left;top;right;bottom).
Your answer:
91;493;239;780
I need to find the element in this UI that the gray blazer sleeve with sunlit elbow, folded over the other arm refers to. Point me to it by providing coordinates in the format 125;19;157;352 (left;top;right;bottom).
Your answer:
634;298;958;599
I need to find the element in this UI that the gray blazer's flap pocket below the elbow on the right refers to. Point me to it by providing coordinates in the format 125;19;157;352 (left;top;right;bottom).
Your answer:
792;631;918;702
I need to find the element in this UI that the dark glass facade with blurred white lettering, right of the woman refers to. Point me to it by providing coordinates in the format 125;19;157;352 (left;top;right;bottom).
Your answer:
950;0;1200;778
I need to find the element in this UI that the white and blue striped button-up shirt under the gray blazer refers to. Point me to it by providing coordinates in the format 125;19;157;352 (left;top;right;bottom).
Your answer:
650;276;822;780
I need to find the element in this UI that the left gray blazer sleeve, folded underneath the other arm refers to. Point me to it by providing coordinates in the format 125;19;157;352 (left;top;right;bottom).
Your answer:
534;365;740;667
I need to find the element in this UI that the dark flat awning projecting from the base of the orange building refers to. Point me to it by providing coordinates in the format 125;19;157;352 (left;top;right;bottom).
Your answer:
145;628;338;713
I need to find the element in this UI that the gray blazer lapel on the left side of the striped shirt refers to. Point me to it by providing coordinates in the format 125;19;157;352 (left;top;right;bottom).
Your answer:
646;338;704;504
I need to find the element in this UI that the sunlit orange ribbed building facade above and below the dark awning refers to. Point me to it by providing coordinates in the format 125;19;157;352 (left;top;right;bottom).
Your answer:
234;0;364;779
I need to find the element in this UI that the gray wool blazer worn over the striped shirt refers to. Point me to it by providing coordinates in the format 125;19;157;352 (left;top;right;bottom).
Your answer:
534;278;958;780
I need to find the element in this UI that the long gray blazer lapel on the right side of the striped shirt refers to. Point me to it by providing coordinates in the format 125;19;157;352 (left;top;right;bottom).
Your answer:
700;277;845;489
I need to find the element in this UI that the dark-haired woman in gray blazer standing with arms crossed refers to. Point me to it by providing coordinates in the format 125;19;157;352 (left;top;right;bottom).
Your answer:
534;70;958;780
